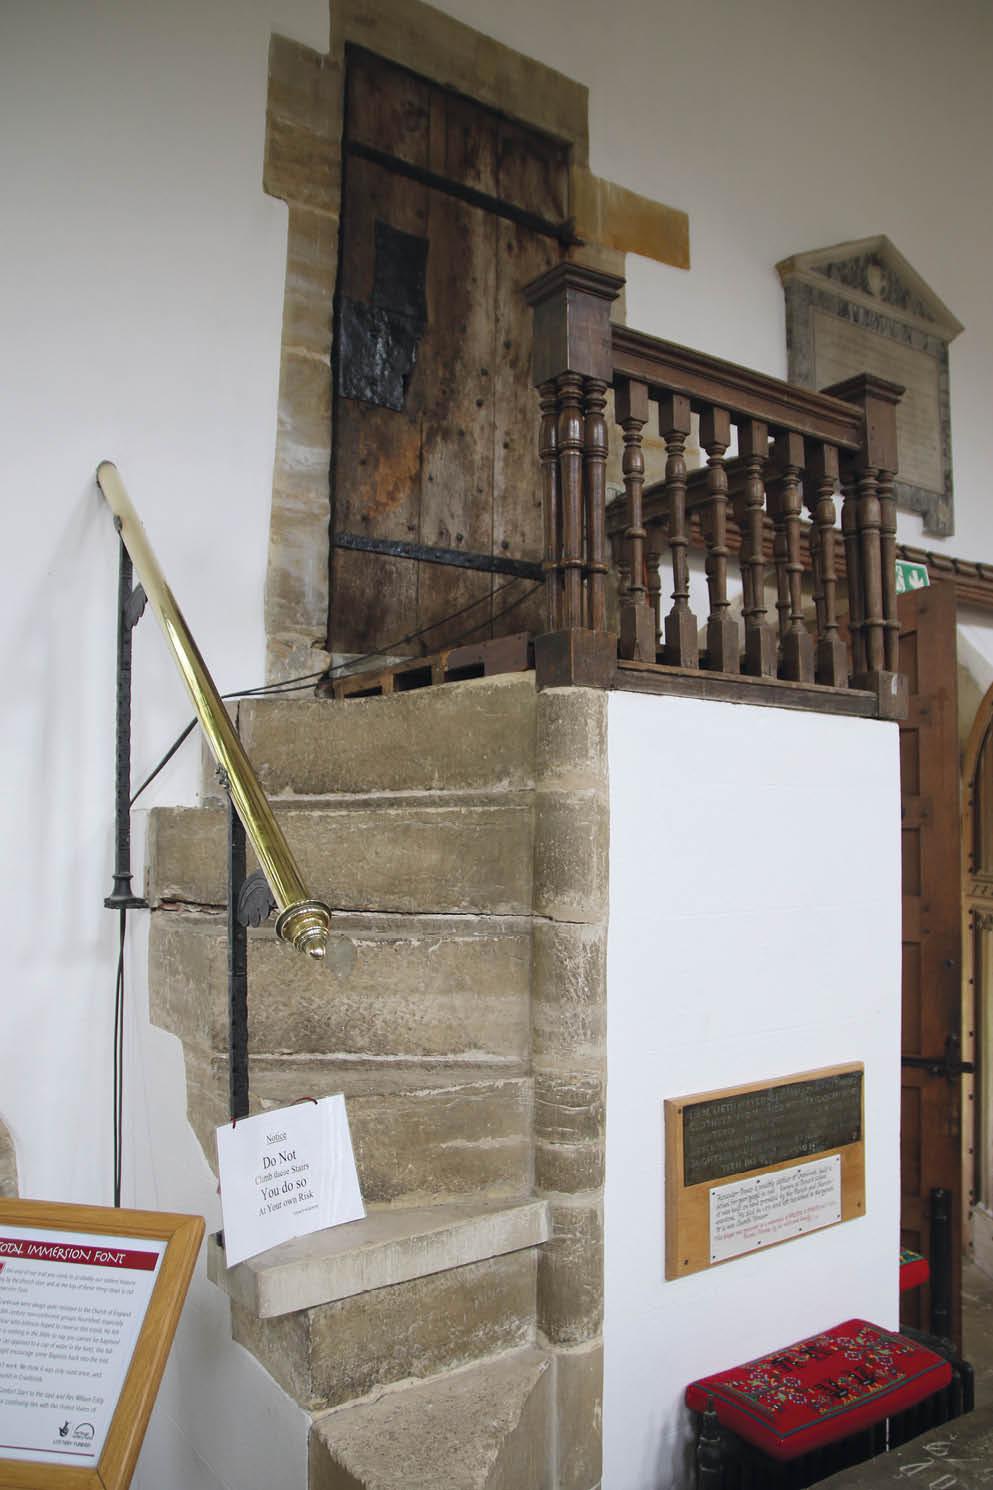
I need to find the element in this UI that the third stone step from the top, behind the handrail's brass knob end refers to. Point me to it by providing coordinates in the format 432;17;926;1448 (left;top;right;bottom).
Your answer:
149;912;531;1068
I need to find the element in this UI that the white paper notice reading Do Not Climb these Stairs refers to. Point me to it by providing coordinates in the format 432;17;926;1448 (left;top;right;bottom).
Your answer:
218;1097;365;1268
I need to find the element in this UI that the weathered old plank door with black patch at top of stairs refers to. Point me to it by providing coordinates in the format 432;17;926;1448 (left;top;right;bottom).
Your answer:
328;51;568;654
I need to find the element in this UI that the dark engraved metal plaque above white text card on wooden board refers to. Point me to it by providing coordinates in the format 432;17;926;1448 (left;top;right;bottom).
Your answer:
683;1071;862;1185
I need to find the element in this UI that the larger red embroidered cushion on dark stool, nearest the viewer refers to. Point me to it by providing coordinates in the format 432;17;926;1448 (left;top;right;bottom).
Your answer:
686;1319;951;1459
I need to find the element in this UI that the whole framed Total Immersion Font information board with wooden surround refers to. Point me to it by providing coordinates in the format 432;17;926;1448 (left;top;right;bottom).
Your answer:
0;1201;204;1490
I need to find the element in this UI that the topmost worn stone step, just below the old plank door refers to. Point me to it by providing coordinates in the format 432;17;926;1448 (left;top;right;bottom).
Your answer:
237;673;537;797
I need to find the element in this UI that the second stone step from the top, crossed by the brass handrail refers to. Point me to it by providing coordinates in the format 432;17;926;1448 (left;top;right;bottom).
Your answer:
146;798;532;915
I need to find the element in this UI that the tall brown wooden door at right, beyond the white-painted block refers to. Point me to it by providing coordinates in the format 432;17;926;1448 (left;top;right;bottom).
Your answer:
899;583;962;1341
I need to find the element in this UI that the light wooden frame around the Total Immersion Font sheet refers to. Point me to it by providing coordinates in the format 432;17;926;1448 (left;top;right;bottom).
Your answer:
0;1199;204;1490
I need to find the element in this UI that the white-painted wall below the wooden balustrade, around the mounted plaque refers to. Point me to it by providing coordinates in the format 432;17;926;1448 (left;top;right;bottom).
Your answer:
604;693;901;1490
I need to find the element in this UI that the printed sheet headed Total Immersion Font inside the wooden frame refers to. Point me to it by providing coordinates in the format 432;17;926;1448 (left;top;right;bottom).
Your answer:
0;1222;166;1471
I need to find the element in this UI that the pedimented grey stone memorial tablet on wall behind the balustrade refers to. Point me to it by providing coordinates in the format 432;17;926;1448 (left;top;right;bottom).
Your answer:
777;234;963;536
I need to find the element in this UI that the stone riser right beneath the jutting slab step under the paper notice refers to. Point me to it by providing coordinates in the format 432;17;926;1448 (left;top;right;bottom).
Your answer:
231;1246;538;1411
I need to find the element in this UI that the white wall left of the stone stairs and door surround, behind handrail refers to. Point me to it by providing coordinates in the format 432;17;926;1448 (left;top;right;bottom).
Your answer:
0;0;328;1490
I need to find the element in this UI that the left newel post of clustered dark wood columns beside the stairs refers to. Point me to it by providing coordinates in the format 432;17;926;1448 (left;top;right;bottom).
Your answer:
525;264;620;687
